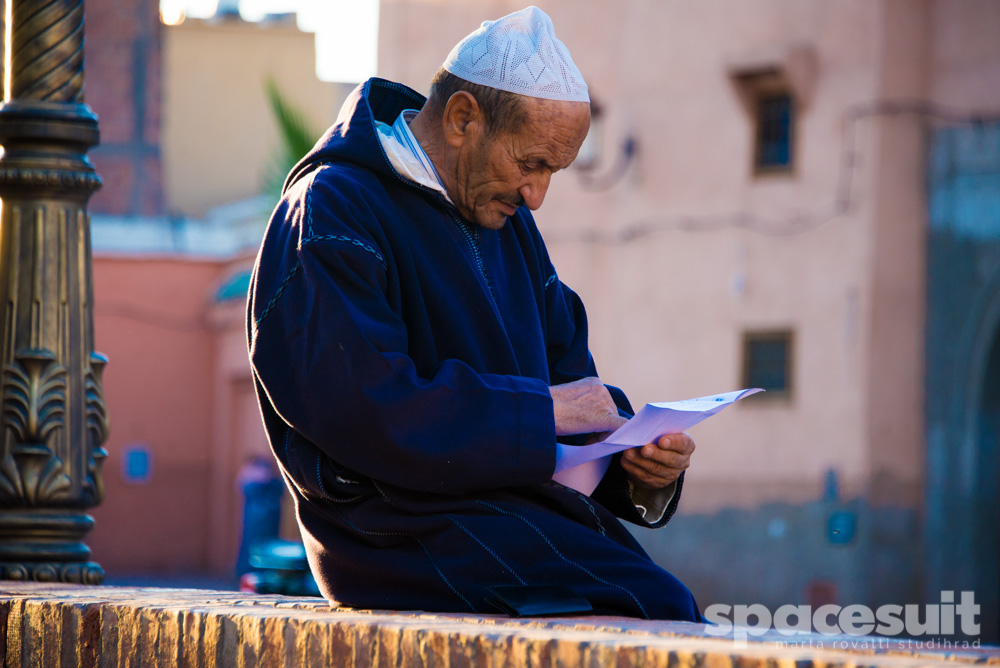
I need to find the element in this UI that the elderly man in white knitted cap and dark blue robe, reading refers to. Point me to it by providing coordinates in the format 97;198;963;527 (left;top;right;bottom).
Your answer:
247;7;701;621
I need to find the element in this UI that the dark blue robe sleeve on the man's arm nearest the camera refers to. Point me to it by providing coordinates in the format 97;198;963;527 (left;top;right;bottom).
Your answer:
250;172;555;494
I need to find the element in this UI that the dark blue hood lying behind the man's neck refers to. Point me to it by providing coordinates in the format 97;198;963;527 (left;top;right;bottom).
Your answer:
282;77;427;193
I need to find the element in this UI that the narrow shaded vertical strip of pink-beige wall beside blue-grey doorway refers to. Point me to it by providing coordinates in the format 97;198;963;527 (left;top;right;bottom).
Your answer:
858;0;932;506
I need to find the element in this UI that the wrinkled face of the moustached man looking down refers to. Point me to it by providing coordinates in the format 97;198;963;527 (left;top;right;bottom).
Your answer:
448;98;590;230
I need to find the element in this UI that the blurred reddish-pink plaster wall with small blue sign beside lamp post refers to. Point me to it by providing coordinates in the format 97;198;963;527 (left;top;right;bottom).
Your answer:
89;257;235;573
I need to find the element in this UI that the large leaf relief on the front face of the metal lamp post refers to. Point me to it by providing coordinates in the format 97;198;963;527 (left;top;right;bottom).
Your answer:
0;349;73;506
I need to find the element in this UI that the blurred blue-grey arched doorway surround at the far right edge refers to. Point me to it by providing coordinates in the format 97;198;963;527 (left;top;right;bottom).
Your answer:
923;123;1000;642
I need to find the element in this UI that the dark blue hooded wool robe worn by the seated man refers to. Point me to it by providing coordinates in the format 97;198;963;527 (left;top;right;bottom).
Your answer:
247;79;700;620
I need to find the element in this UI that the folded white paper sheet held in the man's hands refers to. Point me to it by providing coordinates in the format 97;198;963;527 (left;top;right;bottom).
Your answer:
552;387;763;494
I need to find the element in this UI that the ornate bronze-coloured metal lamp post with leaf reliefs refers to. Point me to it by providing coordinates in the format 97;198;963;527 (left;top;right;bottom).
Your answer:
0;0;108;584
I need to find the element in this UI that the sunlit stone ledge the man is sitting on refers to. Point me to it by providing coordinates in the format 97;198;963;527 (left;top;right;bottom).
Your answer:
0;582;1000;668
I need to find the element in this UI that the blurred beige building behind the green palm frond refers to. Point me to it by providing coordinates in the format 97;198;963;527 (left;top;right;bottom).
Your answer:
163;19;350;216
